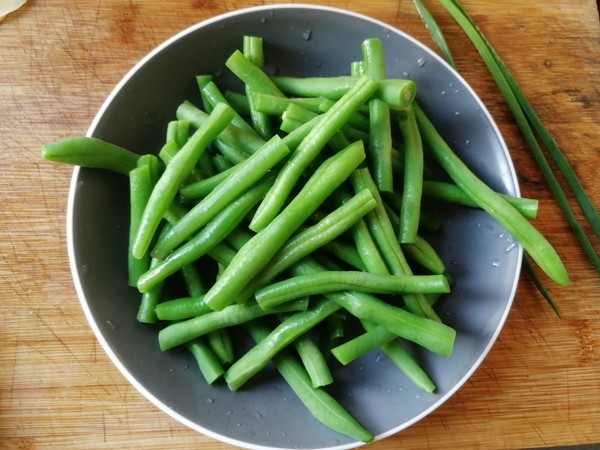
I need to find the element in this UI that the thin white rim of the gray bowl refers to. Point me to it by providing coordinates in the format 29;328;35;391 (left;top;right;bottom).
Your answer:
66;3;523;450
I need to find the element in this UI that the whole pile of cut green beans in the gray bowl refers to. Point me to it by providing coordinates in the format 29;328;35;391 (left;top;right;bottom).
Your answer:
42;36;568;442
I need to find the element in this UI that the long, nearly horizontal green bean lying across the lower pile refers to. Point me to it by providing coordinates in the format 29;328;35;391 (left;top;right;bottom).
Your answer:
255;270;450;309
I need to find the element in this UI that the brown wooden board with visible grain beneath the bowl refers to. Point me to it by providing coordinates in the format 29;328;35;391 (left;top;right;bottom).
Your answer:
0;0;600;450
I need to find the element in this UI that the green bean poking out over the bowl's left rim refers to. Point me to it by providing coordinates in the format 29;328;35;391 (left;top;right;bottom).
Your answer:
42;136;140;175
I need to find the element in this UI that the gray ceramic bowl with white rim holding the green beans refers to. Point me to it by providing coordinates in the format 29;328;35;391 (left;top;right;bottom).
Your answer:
68;5;522;449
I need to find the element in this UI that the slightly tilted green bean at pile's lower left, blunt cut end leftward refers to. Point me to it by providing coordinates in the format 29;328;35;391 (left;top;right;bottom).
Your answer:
158;302;267;350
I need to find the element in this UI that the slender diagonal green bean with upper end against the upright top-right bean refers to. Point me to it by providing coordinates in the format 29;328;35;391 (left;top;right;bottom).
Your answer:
250;77;377;231
